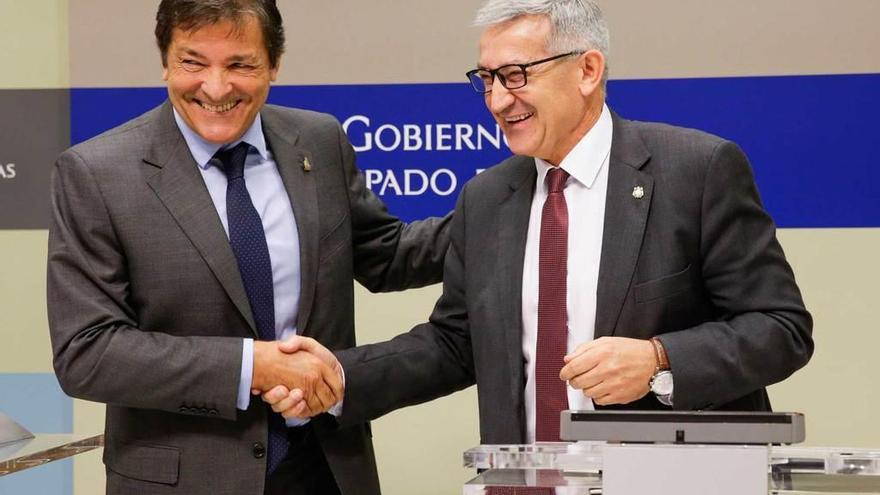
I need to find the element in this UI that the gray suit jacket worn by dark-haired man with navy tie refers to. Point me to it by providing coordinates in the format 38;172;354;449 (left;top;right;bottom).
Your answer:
48;102;448;495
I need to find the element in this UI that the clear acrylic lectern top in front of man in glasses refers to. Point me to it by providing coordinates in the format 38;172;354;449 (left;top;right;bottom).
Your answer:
463;442;880;495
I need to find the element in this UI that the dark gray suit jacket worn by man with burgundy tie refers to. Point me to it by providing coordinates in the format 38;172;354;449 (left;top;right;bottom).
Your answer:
339;115;813;443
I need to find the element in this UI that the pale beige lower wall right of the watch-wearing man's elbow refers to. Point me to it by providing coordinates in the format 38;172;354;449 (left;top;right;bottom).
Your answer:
770;229;880;448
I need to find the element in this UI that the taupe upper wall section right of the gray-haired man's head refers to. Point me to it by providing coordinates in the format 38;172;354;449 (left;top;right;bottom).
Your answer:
598;0;880;79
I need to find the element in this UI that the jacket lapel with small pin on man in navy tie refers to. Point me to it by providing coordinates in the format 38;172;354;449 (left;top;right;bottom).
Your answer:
262;107;321;335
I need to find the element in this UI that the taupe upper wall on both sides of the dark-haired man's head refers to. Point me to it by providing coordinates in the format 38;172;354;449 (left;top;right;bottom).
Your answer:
70;0;479;87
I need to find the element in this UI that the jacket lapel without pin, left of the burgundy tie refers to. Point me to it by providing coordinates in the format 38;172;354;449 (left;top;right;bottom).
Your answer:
497;157;537;430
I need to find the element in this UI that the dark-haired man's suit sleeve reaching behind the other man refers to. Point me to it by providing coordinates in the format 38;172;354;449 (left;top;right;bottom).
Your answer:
337;126;452;292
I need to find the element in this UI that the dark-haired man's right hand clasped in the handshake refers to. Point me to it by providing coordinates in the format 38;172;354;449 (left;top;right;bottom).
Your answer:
252;336;344;414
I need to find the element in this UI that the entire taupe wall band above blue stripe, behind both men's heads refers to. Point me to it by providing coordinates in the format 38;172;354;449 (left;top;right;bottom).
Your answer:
70;0;880;87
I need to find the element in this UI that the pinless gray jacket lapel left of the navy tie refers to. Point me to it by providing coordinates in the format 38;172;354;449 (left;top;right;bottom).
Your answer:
144;102;257;337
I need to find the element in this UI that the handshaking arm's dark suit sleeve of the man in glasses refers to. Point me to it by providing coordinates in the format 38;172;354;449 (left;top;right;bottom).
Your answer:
337;182;475;425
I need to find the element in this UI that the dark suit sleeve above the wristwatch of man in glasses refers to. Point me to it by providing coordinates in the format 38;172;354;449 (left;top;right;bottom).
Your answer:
660;142;813;409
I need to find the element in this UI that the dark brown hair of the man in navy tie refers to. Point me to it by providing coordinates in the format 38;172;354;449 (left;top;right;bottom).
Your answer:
156;0;284;68
